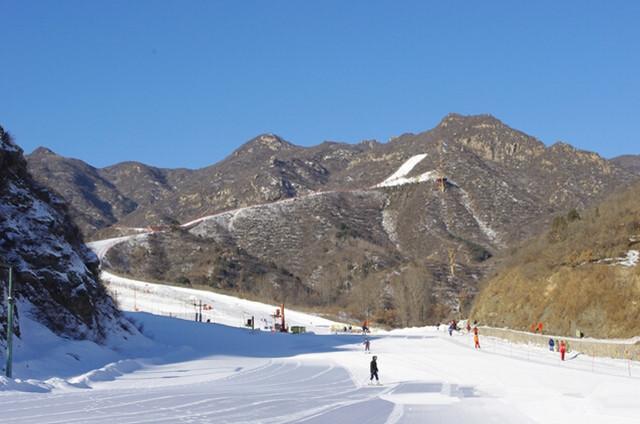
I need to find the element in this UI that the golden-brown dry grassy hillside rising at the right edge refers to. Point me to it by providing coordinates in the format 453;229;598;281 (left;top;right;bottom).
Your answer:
472;185;640;337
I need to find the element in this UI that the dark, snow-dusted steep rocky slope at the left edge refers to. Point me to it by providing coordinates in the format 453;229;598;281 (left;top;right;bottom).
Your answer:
0;127;128;342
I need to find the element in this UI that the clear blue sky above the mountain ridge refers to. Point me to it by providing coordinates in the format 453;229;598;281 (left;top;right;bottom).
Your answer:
0;0;640;168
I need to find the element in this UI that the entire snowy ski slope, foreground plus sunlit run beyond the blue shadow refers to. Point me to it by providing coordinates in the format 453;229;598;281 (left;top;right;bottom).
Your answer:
0;238;640;424
